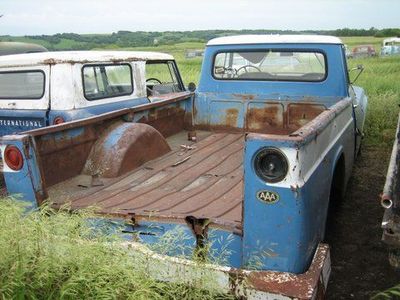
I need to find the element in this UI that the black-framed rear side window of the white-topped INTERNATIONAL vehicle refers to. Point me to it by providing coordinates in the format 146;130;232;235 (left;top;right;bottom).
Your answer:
82;64;133;101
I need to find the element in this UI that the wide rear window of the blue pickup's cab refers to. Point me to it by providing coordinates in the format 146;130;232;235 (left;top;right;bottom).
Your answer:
213;50;326;81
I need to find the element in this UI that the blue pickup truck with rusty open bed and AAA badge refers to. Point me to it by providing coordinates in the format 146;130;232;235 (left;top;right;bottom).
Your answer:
0;35;367;299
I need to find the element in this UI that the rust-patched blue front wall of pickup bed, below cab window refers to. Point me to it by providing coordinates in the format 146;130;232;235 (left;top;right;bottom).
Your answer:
194;94;326;136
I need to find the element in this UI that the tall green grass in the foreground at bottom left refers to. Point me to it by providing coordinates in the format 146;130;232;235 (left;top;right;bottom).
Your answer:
0;199;231;299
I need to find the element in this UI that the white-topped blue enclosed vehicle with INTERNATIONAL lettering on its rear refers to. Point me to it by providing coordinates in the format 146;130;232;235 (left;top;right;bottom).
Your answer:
0;51;184;136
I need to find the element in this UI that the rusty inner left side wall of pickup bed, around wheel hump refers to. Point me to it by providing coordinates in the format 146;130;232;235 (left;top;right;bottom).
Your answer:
23;92;191;187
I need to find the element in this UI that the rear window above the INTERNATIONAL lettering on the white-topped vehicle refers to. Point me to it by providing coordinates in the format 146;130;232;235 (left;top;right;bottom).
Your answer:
0;70;45;100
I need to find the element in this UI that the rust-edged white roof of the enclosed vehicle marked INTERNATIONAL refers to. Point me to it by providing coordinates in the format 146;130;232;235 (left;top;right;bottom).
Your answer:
0;51;174;68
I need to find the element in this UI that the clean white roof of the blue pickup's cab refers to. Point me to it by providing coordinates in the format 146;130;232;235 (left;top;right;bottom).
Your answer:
207;34;343;46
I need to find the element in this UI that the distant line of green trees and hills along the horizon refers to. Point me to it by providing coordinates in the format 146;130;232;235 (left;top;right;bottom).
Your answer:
0;27;400;50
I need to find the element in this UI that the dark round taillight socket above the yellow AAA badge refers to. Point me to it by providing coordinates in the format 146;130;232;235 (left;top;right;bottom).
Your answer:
254;148;288;183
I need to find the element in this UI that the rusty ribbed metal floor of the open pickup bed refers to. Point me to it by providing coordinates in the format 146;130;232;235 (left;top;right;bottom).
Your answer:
49;131;244;233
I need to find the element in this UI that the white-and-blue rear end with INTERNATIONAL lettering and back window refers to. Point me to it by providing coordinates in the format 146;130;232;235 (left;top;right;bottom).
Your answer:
0;65;50;136
